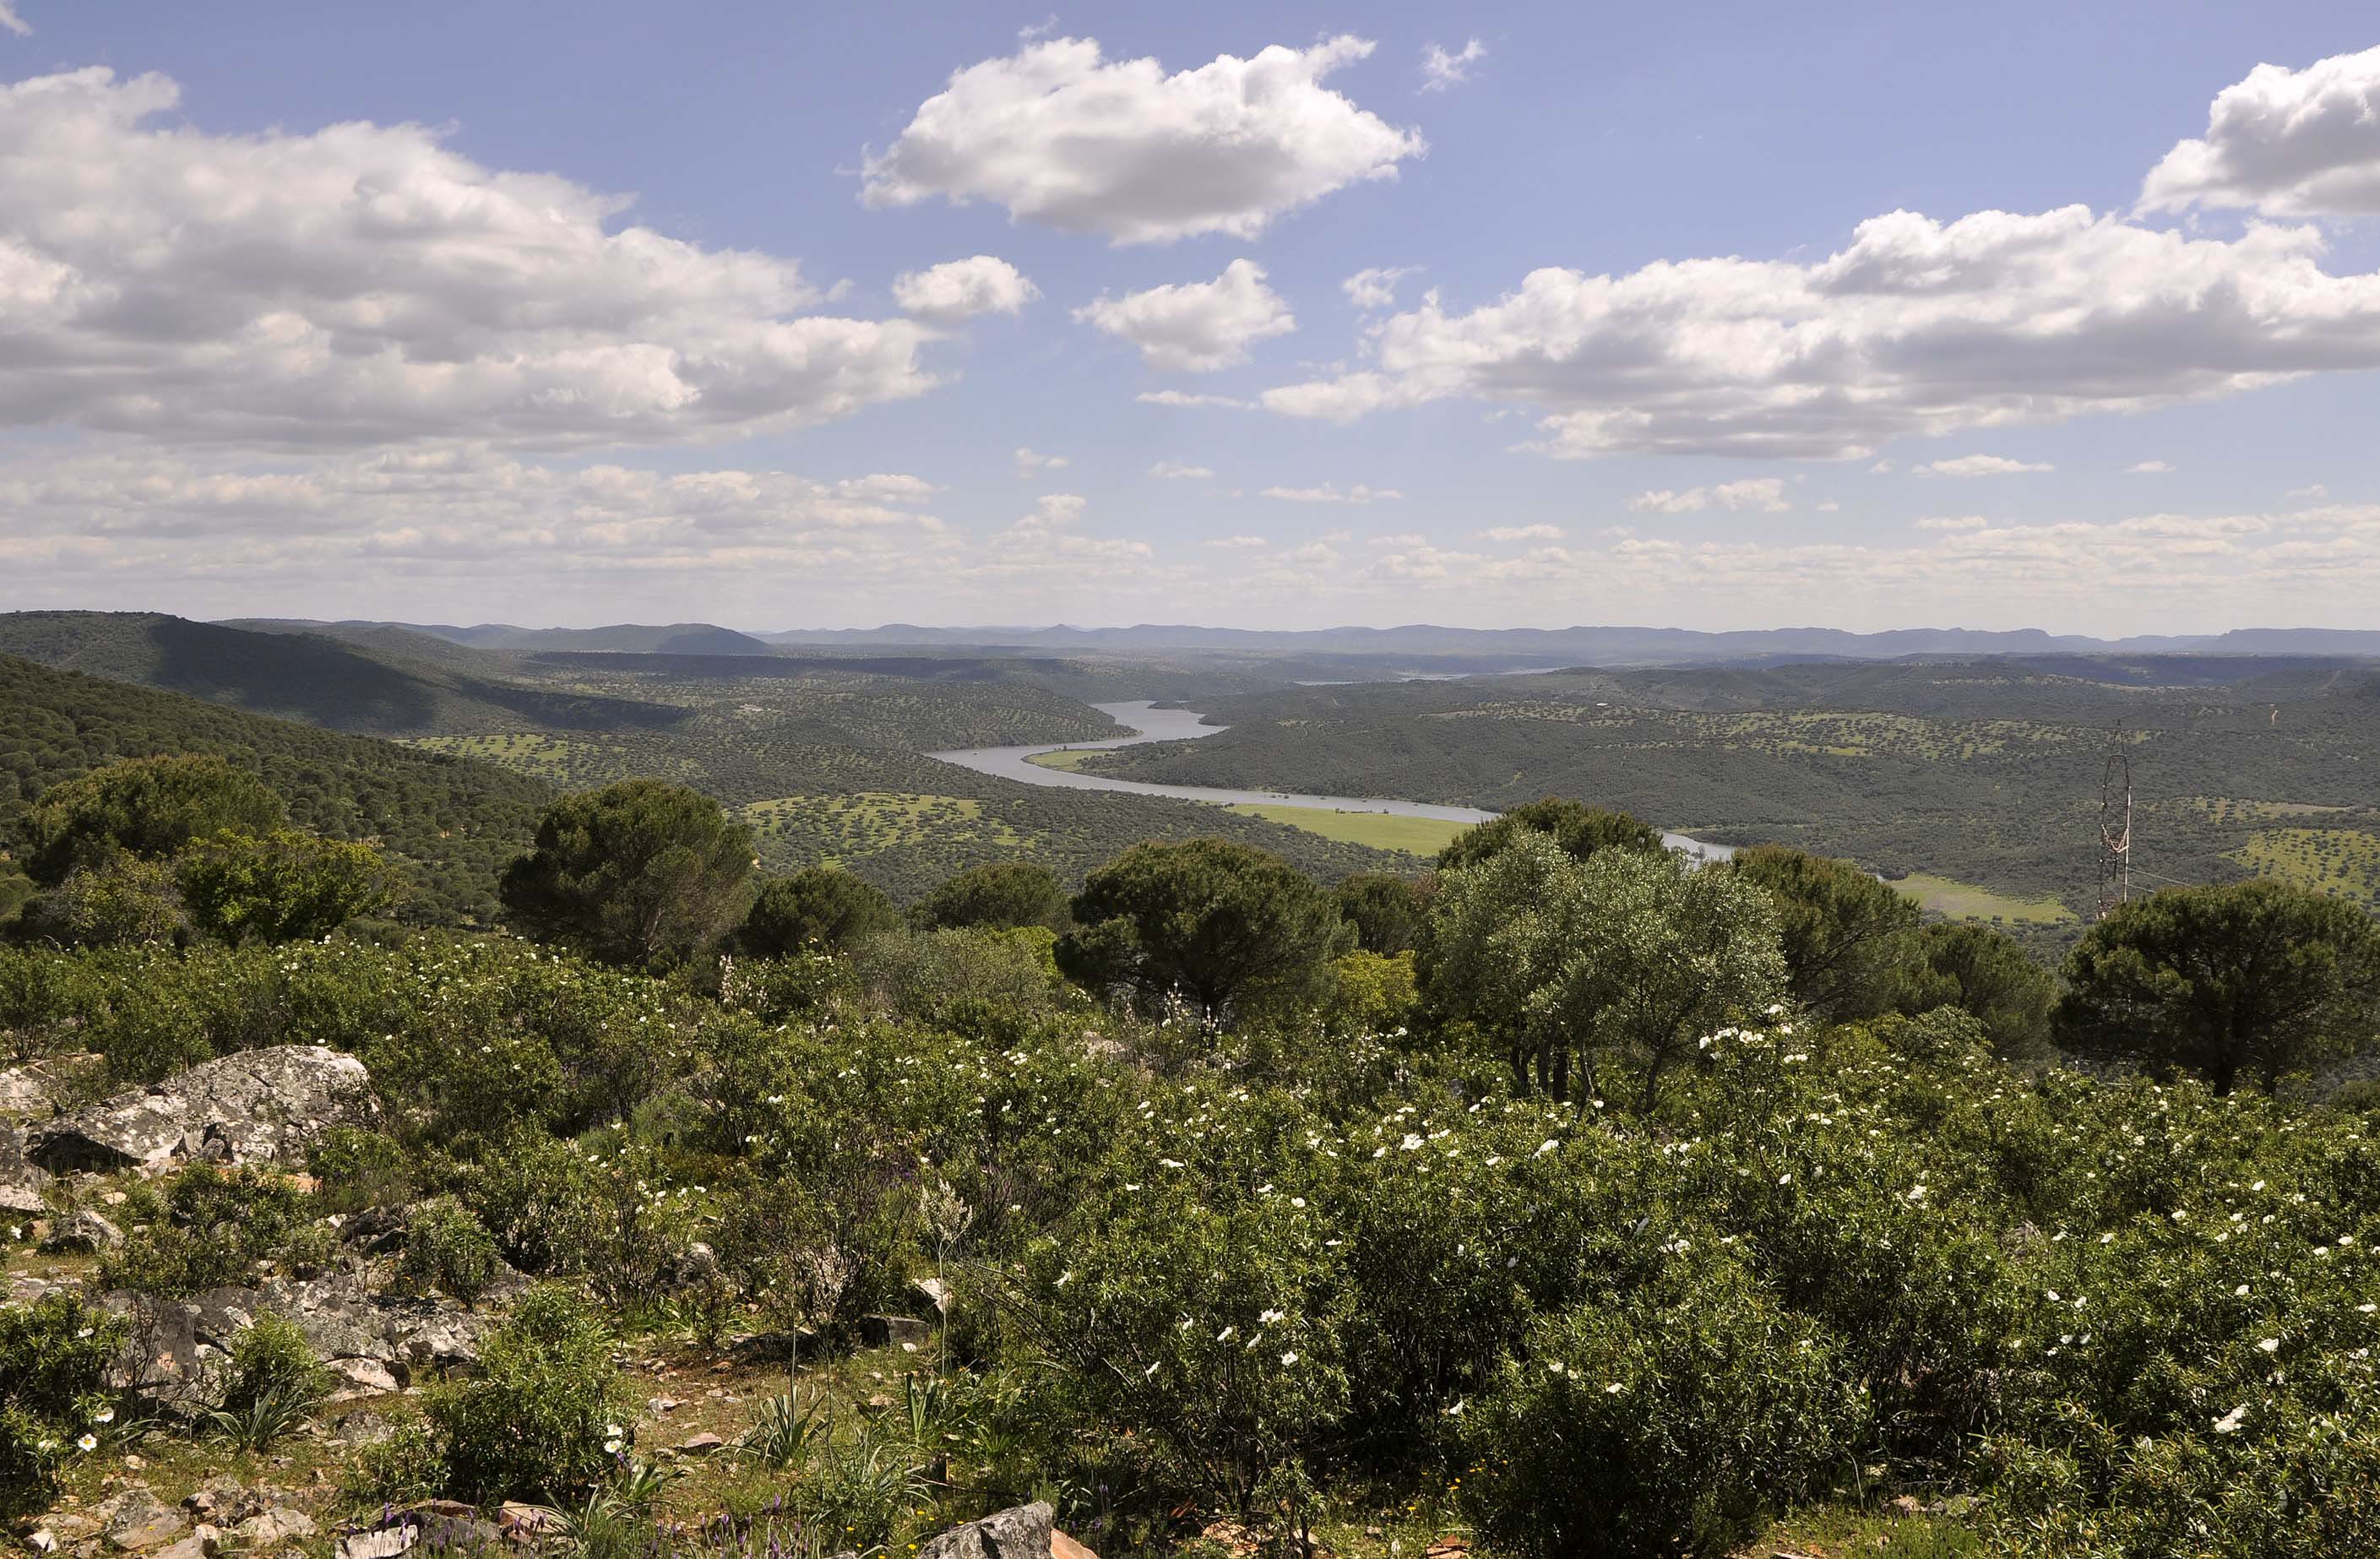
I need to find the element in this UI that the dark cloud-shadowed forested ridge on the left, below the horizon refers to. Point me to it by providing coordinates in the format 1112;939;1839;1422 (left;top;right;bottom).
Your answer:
0;611;687;736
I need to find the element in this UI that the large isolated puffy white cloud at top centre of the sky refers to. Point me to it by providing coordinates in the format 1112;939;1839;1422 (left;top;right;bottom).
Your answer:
861;38;1426;242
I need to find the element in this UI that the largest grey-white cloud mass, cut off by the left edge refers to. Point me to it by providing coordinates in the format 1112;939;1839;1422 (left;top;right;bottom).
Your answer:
0;69;933;448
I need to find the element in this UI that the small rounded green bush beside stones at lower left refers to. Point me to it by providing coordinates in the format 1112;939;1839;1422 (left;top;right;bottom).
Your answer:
424;1285;631;1504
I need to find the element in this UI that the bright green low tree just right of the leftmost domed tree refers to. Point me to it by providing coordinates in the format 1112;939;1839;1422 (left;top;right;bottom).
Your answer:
174;828;388;942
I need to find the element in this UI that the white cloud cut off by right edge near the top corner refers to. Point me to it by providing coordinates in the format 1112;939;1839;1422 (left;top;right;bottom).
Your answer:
2139;47;2380;216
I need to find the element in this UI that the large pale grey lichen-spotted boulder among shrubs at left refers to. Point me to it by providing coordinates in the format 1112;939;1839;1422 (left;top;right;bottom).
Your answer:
26;1045;373;1173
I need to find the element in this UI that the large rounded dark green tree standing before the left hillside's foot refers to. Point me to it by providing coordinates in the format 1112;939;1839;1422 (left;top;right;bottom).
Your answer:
497;779;752;964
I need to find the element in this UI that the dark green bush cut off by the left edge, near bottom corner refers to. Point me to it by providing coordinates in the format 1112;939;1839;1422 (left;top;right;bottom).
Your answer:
0;1292;126;1518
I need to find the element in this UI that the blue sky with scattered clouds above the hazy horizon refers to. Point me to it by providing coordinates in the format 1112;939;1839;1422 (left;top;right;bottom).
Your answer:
0;0;2380;635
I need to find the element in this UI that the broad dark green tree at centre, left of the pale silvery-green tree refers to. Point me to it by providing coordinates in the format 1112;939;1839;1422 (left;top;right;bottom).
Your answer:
1057;840;1354;1024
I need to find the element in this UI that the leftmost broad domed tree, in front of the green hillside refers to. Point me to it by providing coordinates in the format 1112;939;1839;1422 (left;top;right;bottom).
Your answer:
24;754;288;885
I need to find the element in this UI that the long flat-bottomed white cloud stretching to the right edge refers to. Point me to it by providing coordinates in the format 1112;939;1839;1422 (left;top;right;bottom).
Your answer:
1263;207;2380;459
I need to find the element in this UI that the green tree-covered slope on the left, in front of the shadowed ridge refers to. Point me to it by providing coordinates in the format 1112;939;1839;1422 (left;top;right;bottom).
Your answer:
0;656;555;921
